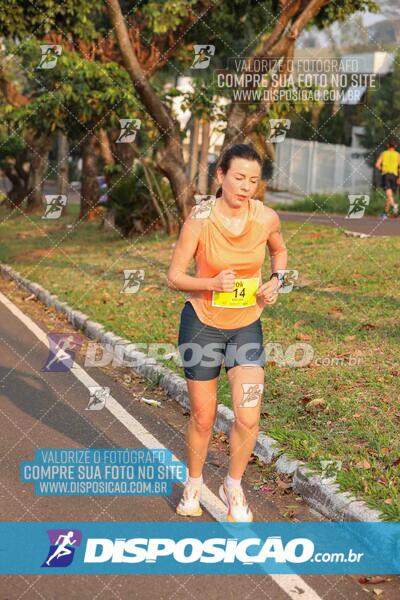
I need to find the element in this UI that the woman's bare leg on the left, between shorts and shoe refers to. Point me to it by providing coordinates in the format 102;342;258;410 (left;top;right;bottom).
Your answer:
186;377;218;477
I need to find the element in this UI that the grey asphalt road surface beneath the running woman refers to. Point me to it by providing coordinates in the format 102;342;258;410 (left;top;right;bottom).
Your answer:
0;278;400;600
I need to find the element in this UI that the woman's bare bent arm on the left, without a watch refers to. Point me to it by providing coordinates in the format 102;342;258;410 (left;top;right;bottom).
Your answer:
167;207;213;292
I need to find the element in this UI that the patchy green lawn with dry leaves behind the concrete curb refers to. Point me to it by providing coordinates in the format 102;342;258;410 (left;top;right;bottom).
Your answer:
0;203;400;521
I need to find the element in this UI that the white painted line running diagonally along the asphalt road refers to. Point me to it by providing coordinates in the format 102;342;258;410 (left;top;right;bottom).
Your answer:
0;292;321;600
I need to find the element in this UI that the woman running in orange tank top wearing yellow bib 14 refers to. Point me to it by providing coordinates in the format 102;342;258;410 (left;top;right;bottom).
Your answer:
168;144;287;521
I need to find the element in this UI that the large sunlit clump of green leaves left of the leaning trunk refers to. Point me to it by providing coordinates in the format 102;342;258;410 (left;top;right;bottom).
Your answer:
6;41;140;139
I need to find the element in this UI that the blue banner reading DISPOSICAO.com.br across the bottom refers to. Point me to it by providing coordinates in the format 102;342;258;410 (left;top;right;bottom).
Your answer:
0;522;400;575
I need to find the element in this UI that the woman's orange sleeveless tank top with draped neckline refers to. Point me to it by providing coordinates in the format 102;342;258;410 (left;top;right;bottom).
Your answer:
185;198;268;329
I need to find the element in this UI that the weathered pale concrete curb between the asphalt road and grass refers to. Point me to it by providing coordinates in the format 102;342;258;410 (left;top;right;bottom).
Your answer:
0;264;382;522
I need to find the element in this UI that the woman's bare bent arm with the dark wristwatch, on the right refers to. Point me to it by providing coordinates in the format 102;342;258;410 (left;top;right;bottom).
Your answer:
257;207;287;306
